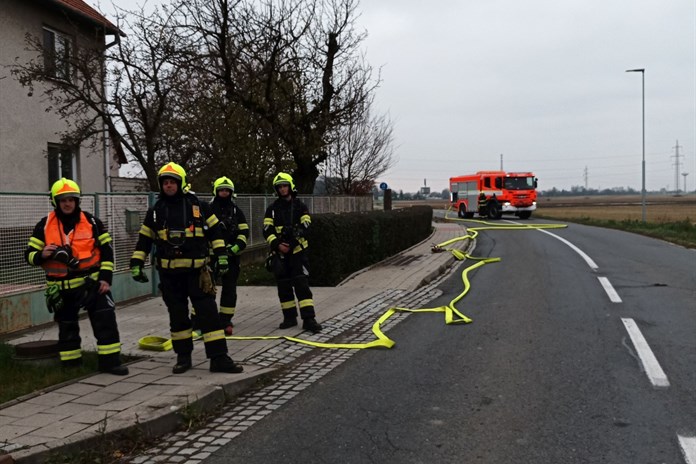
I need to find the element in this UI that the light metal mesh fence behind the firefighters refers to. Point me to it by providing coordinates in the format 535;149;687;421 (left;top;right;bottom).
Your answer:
0;192;372;296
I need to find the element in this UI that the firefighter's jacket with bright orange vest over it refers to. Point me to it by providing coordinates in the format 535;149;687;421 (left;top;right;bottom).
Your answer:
24;208;114;289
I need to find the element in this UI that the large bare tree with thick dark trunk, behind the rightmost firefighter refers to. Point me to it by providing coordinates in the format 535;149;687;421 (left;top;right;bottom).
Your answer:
171;0;378;193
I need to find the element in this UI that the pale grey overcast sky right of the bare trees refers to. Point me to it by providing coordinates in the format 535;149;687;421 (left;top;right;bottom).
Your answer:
103;0;696;192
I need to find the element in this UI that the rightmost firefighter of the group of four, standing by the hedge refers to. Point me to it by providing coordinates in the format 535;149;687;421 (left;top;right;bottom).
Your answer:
263;172;321;333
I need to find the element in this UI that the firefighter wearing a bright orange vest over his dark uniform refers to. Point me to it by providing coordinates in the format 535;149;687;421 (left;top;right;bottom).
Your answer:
24;178;128;375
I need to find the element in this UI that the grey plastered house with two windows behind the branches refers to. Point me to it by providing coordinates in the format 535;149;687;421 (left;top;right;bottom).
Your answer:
0;0;126;192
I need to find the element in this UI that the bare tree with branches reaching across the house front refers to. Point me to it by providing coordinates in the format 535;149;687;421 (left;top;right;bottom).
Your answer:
11;5;186;189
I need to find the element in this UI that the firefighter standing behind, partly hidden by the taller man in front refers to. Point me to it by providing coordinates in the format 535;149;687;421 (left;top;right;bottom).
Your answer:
206;176;249;335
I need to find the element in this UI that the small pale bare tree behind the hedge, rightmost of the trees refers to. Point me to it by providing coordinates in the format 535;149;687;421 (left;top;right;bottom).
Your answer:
324;100;394;195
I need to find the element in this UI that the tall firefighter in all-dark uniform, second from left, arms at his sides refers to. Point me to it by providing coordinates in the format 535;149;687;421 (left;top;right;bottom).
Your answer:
130;163;243;374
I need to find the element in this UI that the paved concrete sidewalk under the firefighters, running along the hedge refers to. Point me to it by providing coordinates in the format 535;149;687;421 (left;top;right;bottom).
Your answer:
0;223;469;464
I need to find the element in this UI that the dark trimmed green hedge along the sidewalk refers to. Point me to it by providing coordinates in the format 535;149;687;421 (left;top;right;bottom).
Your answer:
308;206;433;286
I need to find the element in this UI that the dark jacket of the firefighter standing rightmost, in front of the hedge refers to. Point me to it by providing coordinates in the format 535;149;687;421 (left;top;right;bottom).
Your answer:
263;197;312;253
